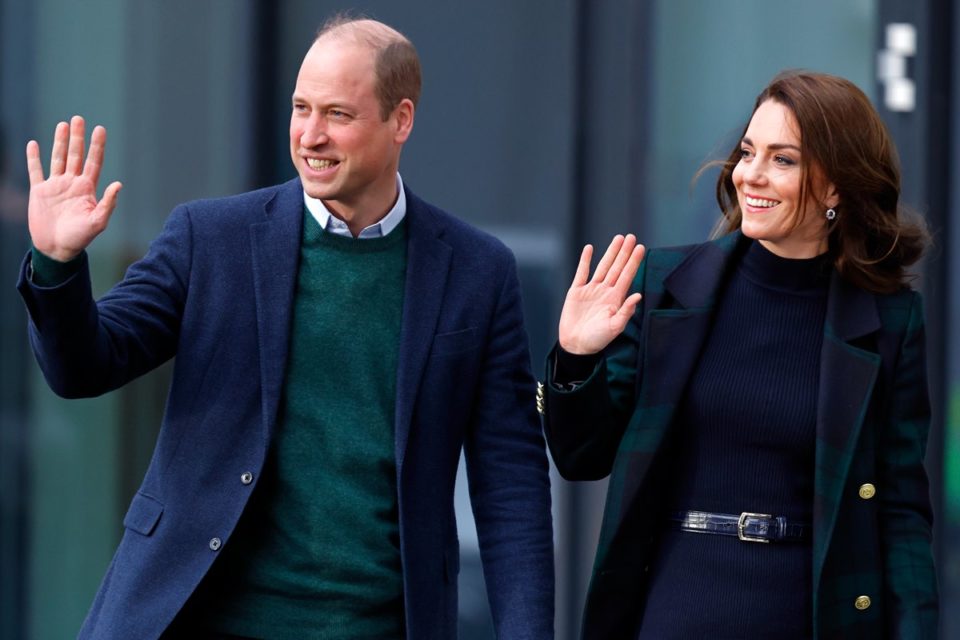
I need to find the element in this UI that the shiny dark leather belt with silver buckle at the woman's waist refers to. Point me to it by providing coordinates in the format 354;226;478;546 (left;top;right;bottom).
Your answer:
668;511;812;542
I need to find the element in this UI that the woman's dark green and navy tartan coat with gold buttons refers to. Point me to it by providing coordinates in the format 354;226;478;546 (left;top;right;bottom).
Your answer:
543;232;938;640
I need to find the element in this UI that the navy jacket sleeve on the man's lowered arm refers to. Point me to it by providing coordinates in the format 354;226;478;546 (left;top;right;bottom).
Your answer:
464;256;554;640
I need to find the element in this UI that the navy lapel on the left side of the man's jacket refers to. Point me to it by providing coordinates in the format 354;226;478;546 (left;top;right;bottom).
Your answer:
250;180;304;442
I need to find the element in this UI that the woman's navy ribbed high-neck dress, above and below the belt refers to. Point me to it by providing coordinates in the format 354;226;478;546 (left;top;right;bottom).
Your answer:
639;242;830;640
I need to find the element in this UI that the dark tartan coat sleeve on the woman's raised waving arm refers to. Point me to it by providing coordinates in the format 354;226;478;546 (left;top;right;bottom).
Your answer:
543;261;647;480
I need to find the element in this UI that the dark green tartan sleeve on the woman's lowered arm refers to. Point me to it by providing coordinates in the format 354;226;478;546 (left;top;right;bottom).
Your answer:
877;294;938;639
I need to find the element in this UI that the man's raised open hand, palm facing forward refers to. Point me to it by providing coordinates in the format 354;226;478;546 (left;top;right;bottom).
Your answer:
27;116;121;262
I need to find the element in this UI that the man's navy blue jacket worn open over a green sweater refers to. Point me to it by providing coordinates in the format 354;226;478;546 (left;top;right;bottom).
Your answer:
18;179;553;640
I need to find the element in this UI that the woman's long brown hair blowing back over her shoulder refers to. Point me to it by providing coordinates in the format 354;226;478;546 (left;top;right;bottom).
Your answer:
717;71;929;293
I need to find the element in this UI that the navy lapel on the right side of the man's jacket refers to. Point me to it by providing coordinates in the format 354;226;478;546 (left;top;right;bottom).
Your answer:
395;190;453;476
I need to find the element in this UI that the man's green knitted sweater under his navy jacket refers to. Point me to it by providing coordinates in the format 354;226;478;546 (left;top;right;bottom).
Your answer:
199;213;406;640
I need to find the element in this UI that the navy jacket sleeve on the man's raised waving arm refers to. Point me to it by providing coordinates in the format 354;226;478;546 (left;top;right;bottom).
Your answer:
17;206;190;398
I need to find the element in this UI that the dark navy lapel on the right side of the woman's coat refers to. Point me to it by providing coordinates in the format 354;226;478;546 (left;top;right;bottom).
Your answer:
813;273;881;602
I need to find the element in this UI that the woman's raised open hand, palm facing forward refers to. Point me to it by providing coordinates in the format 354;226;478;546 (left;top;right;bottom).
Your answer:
560;234;645;354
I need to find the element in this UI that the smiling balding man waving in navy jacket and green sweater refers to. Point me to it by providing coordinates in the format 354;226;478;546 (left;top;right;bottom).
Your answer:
18;18;553;640
